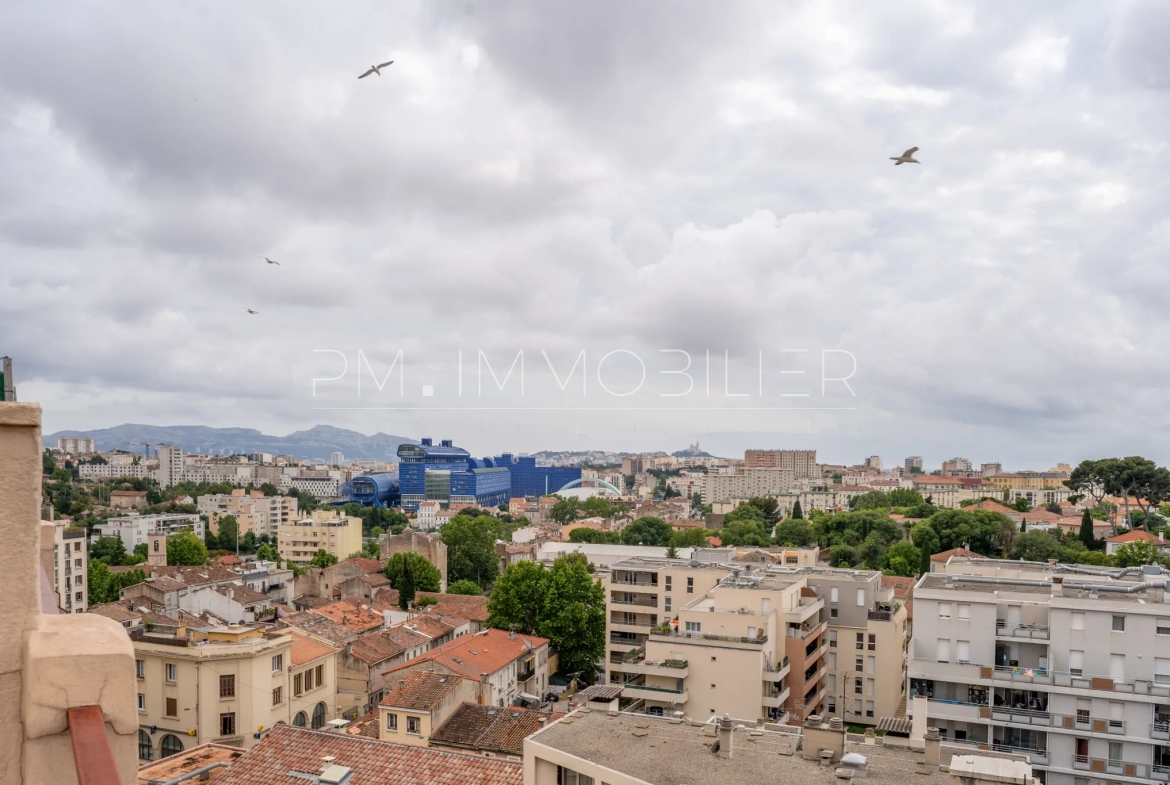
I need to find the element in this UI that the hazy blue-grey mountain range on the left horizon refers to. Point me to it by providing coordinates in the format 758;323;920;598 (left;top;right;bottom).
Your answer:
44;424;418;461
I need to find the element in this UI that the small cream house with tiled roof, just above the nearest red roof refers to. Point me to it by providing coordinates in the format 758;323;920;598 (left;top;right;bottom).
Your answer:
378;670;480;746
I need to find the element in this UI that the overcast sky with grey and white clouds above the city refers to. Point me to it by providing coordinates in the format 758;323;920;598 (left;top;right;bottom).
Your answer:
0;0;1170;469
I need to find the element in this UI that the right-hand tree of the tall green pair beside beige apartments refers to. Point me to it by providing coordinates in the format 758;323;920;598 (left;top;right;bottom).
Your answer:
538;558;605;674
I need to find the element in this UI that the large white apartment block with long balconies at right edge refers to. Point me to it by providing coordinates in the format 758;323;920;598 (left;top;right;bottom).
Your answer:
908;557;1170;785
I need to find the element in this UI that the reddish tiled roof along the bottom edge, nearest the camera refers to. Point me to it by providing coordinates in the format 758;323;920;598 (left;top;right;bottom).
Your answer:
210;725;524;785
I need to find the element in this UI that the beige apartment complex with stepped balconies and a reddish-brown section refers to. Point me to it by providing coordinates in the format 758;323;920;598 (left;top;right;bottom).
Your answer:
601;559;907;725
